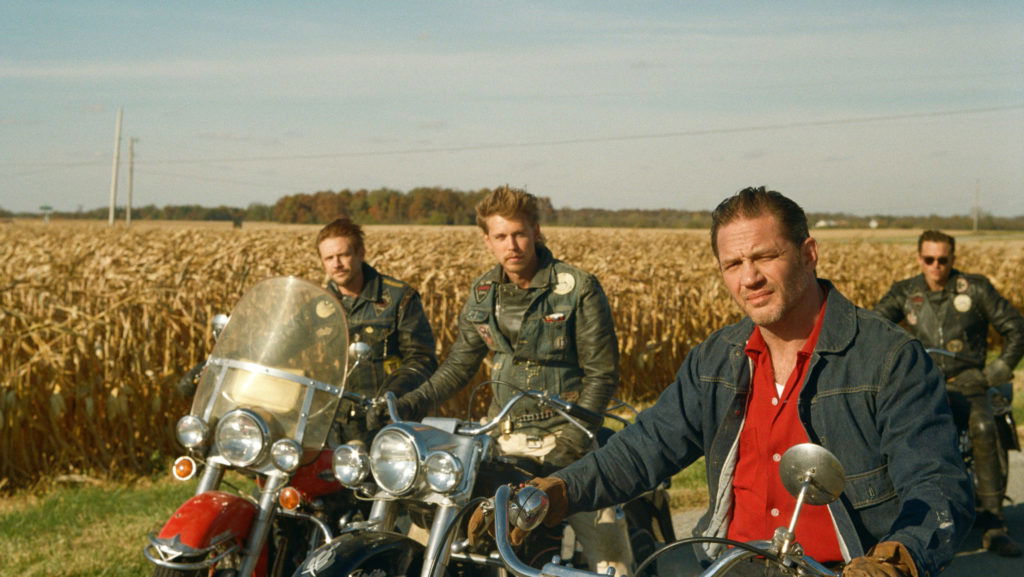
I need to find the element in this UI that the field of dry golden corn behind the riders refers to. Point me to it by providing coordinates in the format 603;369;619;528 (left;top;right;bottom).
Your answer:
0;221;1024;491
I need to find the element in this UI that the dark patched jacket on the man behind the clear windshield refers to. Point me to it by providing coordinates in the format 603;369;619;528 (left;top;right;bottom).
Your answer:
328;262;437;437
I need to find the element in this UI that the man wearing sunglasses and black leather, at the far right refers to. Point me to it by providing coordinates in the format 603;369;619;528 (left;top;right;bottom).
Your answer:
874;231;1024;557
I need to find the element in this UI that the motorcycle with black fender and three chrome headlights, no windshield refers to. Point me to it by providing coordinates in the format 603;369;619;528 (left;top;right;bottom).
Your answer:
296;383;668;577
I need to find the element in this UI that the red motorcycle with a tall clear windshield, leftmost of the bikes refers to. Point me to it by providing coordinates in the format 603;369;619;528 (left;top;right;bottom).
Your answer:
143;277;368;577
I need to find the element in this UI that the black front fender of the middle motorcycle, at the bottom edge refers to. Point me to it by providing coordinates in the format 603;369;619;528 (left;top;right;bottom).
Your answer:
293;530;424;577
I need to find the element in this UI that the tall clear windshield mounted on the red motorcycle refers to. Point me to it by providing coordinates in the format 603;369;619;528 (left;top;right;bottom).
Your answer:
191;277;348;451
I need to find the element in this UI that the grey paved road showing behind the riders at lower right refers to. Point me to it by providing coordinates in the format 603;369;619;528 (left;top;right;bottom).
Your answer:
660;451;1024;577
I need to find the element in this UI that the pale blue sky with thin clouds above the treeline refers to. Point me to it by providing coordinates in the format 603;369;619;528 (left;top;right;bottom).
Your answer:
0;0;1024;216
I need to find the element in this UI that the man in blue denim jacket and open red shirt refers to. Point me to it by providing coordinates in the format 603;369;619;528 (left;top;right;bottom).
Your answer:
495;188;974;577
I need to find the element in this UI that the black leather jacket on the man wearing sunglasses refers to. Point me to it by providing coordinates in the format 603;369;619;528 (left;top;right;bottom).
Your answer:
874;269;1024;378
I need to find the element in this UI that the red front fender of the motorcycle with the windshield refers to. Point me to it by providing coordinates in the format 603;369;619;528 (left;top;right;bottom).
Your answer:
154;491;256;554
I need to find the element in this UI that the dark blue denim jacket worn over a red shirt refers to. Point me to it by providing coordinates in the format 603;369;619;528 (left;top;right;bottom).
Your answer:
555;281;974;577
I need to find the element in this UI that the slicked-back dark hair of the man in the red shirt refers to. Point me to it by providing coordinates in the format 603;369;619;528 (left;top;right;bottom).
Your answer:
711;187;811;258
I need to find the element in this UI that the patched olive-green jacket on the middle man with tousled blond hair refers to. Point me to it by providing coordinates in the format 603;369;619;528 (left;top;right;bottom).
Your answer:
403;246;618;443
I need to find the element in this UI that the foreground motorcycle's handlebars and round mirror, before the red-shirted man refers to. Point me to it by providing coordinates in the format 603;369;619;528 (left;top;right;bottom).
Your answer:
493;443;846;577
